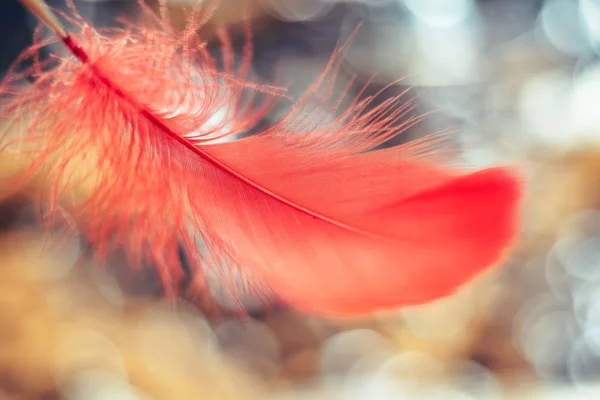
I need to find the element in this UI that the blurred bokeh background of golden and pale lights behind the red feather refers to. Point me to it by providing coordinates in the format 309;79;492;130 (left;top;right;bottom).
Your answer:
0;0;600;400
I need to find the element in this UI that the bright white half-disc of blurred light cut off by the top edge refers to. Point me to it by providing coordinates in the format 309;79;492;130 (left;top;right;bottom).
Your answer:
400;0;474;27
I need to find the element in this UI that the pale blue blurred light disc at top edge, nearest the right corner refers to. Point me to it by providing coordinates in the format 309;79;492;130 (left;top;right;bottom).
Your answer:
538;0;589;55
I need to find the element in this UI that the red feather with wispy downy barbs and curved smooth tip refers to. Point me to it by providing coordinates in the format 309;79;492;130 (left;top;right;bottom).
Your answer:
1;1;521;315
